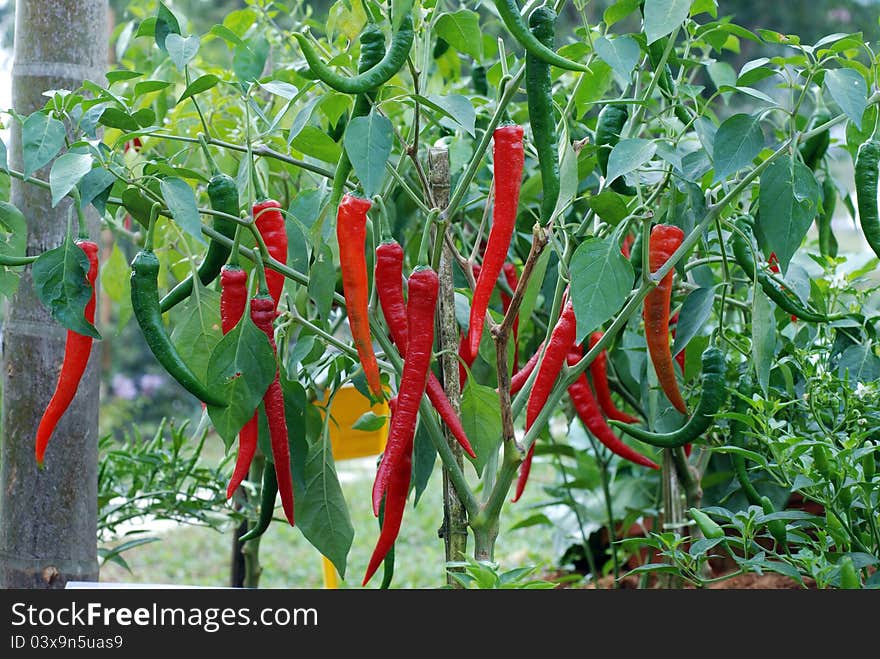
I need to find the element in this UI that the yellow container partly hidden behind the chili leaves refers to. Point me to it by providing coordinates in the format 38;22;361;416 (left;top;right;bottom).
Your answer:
321;385;388;461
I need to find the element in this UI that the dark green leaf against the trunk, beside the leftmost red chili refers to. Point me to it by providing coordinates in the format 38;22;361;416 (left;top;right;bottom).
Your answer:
32;236;101;339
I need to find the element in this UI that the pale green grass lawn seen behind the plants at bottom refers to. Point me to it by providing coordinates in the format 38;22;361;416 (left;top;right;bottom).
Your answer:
100;448;554;588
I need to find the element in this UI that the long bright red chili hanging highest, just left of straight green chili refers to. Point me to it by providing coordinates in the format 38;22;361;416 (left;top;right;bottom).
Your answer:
468;124;525;355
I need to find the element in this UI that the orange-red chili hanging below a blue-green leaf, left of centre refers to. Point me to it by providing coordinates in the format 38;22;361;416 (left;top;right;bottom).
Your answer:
336;194;382;398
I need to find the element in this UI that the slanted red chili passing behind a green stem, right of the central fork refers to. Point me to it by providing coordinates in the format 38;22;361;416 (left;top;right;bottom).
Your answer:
513;300;577;502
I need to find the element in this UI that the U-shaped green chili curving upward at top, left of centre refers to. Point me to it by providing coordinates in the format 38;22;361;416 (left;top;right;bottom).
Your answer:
293;14;414;94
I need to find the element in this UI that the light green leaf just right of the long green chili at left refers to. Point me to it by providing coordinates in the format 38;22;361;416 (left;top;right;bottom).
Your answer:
171;277;222;380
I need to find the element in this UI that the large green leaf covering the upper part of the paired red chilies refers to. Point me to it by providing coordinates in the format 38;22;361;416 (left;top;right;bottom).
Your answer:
206;310;277;449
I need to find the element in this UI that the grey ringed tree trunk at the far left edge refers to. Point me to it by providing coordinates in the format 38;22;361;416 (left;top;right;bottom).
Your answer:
0;0;108;588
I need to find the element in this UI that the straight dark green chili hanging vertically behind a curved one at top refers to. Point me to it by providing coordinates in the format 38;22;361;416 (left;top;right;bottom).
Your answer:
526;5;559;224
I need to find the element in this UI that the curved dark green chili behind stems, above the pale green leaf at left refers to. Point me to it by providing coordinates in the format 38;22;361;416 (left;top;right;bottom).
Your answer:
159;148;239;313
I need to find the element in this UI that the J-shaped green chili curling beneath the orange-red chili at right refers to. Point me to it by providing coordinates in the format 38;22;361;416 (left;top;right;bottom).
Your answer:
608;346;727;448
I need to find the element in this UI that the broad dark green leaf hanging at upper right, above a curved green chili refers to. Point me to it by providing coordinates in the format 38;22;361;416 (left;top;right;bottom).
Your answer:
755;155;820;274
